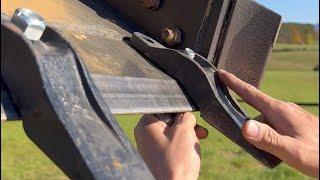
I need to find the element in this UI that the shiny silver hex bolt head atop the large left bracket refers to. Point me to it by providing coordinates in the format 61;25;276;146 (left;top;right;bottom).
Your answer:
11;8;46;41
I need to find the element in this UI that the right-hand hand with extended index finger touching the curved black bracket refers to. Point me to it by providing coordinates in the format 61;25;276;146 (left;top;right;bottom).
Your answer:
218;70;319;178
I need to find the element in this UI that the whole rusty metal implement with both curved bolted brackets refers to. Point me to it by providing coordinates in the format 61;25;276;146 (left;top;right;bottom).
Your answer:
1;0;281;179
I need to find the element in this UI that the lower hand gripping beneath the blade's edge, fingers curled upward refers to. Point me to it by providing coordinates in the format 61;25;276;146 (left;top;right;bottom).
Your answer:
134;113;208;180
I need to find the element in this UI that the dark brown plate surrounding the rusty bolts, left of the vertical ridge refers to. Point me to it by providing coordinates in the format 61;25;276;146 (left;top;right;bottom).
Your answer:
94;0;225;56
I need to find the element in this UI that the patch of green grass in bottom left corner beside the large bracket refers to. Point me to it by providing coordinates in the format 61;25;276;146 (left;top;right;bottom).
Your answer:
1;121;66;180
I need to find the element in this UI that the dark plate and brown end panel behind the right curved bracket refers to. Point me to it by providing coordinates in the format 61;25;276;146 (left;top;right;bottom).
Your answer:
95;0;281;87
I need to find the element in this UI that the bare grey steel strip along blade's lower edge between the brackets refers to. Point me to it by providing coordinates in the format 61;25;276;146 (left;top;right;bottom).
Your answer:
1;74;196;120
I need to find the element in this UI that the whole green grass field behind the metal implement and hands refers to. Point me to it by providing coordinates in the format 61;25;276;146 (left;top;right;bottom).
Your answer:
1;45;319;180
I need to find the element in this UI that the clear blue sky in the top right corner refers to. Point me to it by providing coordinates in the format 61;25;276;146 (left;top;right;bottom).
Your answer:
256;0;319;24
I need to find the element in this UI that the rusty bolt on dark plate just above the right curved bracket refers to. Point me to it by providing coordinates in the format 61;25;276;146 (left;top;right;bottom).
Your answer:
161;27;182;46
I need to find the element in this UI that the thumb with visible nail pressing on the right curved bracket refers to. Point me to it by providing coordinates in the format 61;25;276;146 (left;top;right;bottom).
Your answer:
242;120;286;159
